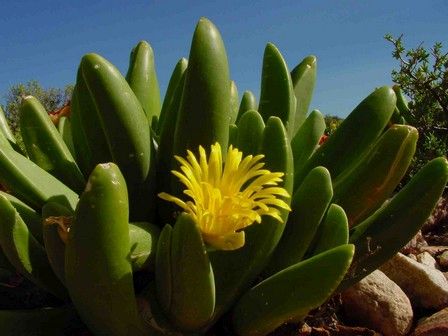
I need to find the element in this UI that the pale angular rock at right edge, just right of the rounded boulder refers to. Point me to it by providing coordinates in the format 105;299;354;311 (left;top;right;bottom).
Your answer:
380;253;448;309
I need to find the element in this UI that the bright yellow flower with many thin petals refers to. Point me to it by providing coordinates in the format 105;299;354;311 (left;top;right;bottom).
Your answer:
159;143;290;250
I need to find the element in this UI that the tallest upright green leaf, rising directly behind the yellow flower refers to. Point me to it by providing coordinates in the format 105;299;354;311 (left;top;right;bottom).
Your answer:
173;18;232;156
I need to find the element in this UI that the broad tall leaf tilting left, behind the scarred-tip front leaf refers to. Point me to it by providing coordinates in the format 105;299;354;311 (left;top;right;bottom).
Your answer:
80;54;155;221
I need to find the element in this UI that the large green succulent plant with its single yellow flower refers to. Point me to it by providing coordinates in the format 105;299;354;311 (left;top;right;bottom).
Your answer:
0;18;448;336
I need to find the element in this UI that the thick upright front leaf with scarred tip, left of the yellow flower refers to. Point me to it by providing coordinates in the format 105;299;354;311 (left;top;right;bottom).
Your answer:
65;163;146;335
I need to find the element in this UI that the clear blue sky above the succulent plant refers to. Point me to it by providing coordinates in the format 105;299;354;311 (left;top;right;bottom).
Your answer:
0;0;448;116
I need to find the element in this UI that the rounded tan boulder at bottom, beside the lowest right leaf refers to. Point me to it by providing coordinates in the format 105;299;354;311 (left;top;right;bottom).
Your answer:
342;270;413;336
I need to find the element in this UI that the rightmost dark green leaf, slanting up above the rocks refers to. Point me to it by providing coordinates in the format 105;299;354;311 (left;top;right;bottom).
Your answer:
339;157;448;291
